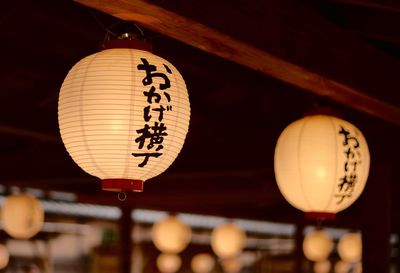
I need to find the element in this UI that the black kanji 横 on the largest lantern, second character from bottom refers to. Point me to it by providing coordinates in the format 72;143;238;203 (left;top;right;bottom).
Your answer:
135;122;168;151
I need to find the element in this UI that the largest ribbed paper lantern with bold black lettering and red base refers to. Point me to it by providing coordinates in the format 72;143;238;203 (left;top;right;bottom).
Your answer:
58;43;190;191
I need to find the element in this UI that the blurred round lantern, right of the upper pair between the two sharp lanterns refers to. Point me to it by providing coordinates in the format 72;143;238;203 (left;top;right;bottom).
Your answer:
211;223;246;258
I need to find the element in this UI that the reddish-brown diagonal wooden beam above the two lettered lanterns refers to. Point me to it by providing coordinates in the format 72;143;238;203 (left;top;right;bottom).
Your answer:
76;0;400;125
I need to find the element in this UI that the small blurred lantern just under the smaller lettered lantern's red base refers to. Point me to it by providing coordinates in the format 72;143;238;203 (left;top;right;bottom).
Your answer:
303;230;333;262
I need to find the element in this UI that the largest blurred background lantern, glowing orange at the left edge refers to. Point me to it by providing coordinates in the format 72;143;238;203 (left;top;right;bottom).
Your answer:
2;194;44;239
